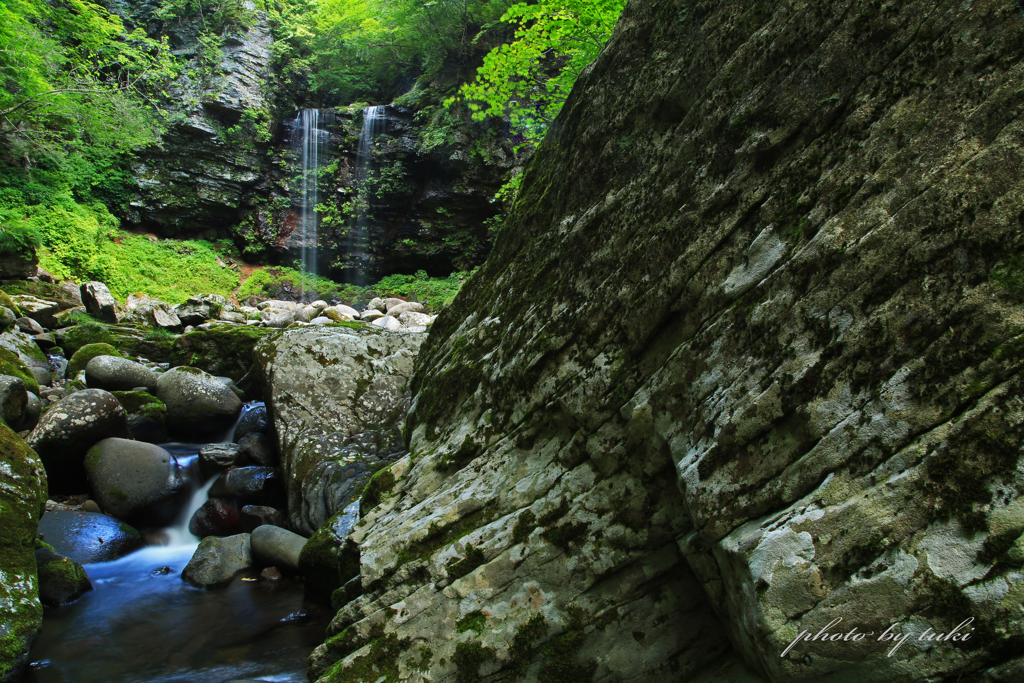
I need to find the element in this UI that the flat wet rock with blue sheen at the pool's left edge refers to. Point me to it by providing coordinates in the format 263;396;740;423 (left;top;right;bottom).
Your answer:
39;510;145;564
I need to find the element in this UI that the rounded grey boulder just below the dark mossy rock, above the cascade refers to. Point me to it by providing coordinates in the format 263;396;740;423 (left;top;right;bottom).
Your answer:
157;368;242;440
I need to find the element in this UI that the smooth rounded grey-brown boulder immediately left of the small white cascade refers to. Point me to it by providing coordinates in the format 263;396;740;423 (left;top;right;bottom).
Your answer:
85;438;187;526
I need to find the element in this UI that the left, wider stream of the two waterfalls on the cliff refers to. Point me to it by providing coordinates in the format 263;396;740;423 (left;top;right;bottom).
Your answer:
292;110;335;301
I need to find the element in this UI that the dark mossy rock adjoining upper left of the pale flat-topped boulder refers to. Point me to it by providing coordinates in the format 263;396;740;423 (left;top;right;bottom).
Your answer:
170;325;280;380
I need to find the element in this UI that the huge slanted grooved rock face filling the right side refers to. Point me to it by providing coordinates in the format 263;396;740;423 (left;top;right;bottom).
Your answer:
312;0;1024;683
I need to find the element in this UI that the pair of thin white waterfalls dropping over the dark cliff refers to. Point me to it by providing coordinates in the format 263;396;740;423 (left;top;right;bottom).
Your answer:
291;106;385;294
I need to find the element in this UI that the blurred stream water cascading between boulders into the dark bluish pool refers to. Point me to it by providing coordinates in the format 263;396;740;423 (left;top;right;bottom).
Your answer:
26;403;333;683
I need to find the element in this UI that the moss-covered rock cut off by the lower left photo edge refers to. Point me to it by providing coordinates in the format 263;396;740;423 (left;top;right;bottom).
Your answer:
0;424;46;681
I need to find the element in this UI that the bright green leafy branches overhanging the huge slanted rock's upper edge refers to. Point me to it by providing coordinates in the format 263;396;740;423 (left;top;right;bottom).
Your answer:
444;0;626;141
